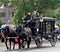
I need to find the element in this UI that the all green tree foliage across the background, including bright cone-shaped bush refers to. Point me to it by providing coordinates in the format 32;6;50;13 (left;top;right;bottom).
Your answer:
0;0;60;25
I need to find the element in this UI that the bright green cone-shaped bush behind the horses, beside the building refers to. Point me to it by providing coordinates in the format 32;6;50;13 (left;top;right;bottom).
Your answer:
11;9;23;25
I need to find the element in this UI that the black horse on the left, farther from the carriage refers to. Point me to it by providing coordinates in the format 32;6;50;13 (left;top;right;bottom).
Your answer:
2;26;17;49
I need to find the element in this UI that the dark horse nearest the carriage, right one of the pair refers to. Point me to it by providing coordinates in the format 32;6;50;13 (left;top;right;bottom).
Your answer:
16;26;31;48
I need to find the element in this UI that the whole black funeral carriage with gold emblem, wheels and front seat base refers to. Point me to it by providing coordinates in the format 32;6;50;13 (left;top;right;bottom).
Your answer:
23;17;57;47
